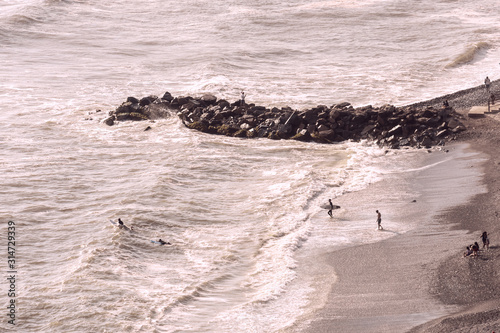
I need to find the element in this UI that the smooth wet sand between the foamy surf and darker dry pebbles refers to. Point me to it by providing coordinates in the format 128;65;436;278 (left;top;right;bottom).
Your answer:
286;144;484;332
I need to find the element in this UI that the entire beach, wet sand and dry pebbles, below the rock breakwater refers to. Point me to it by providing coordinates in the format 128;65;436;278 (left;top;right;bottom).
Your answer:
287;81;500;333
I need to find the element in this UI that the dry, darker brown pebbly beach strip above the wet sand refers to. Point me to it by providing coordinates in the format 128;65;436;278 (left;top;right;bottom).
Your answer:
409;115;500;333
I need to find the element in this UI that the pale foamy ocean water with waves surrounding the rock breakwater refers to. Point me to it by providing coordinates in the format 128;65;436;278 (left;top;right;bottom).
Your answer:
0;0;500;332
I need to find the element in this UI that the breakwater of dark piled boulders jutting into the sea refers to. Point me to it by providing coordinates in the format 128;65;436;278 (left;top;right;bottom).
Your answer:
104;92;466;148
